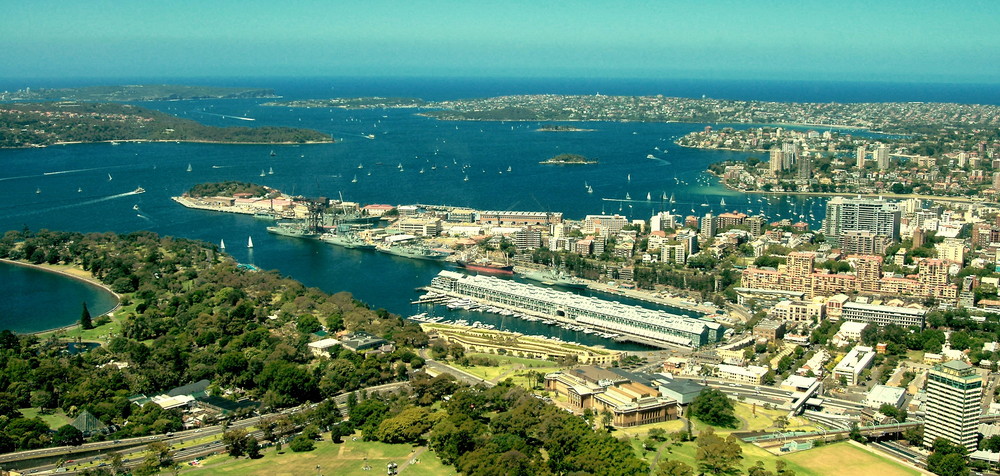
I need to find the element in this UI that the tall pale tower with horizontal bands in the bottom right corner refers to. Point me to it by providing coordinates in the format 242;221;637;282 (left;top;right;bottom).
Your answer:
924;360;983;451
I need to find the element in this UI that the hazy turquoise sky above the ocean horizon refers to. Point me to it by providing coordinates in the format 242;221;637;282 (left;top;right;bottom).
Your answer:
0;0;1000;84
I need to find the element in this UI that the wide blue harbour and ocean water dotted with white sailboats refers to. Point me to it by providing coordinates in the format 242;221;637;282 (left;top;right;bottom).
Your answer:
0;78;1000;346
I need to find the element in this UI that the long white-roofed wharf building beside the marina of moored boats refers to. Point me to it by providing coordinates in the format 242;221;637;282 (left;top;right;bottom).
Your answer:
430;271;725;347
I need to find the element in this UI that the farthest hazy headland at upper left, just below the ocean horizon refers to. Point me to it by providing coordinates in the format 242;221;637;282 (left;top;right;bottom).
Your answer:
0;84;278;102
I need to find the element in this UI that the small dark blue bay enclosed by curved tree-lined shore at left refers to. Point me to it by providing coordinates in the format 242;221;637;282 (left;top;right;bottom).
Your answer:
0;263;117;332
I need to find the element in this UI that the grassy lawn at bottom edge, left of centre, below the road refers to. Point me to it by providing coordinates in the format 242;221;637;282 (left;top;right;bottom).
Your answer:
182;438;456;476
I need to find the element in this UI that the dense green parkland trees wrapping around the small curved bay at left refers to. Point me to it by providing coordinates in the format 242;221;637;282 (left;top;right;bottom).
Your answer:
0;231;427;451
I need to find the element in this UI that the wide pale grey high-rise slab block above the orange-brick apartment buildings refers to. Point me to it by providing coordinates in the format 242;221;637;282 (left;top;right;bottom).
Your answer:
823;197;901;246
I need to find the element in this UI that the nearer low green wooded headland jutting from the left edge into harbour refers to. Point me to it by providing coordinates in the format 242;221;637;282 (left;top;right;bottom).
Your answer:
0;102;333;148
